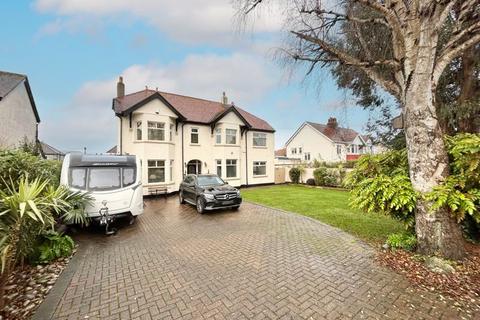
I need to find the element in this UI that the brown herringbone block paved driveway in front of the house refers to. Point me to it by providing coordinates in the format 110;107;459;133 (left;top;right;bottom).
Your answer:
36;197;472;320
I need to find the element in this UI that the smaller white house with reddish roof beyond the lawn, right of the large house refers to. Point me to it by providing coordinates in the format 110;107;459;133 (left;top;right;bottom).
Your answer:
285;118;378;162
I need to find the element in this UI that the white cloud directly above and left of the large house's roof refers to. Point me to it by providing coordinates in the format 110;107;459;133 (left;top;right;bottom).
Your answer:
40;53;278;152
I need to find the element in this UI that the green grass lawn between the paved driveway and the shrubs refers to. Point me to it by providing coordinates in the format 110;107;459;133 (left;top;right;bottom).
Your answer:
242;185;404;243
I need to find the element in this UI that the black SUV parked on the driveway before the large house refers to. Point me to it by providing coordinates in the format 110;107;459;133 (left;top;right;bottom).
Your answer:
178;174;242;213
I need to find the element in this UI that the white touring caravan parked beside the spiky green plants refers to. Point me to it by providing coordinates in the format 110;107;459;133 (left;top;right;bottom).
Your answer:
60;153;143;229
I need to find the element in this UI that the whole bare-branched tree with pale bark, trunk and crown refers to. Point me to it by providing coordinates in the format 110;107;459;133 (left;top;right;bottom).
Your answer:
238;0;480;259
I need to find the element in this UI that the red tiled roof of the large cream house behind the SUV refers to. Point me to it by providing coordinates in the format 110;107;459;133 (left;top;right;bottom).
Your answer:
113;90;274;131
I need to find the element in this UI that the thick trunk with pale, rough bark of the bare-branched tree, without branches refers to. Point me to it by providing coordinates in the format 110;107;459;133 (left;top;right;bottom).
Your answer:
404;21;465;259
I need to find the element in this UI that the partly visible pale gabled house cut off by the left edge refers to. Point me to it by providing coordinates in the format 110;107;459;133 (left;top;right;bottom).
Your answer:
0;71;40;148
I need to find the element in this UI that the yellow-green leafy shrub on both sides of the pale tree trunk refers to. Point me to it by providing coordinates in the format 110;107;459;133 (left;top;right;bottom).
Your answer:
345;134;480;235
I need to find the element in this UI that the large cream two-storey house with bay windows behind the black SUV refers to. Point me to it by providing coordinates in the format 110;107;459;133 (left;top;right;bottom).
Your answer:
109;77;275;194
